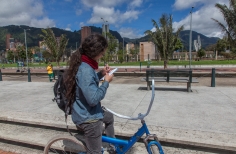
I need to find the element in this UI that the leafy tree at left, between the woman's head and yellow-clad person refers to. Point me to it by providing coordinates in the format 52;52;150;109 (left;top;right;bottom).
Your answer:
40;28;68;66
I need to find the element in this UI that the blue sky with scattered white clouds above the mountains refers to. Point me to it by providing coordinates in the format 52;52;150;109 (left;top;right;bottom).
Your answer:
0;0;228;38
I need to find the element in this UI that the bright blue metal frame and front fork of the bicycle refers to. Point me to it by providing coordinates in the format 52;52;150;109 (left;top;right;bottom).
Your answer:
102;120;164;154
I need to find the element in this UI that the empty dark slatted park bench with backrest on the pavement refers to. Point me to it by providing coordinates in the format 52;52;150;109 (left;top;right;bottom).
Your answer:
141;69;198;92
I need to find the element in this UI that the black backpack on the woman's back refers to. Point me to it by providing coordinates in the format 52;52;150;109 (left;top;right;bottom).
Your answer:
52;70;71;118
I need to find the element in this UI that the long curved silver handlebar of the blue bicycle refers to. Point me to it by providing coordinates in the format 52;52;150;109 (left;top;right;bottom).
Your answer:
104;79;155;120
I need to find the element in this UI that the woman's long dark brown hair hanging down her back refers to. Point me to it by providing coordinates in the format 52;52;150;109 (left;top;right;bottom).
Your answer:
65;34;108;106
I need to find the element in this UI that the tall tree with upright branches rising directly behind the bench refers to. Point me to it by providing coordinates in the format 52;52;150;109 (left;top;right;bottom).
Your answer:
145;14;184;69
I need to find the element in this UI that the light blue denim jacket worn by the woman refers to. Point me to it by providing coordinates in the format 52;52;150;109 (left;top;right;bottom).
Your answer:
71;62;109;125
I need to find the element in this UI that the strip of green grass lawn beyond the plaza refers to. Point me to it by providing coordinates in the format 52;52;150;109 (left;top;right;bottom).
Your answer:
0;60;236;68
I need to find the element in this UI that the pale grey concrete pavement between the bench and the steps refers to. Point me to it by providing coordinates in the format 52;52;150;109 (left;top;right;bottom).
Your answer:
0;81;236;150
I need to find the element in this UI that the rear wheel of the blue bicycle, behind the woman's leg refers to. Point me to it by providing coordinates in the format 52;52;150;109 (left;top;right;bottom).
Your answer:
44;135;87;154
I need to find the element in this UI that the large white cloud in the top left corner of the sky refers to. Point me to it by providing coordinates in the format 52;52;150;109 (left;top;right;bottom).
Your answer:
0;0;55;28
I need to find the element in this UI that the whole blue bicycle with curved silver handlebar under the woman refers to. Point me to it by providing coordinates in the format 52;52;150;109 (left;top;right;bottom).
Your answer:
44;80;164;154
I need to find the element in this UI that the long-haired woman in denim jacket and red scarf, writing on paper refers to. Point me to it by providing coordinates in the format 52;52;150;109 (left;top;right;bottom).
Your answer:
65;34;115;154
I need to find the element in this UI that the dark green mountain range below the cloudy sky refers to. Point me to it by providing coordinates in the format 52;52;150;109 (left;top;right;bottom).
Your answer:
0;25;219;51
